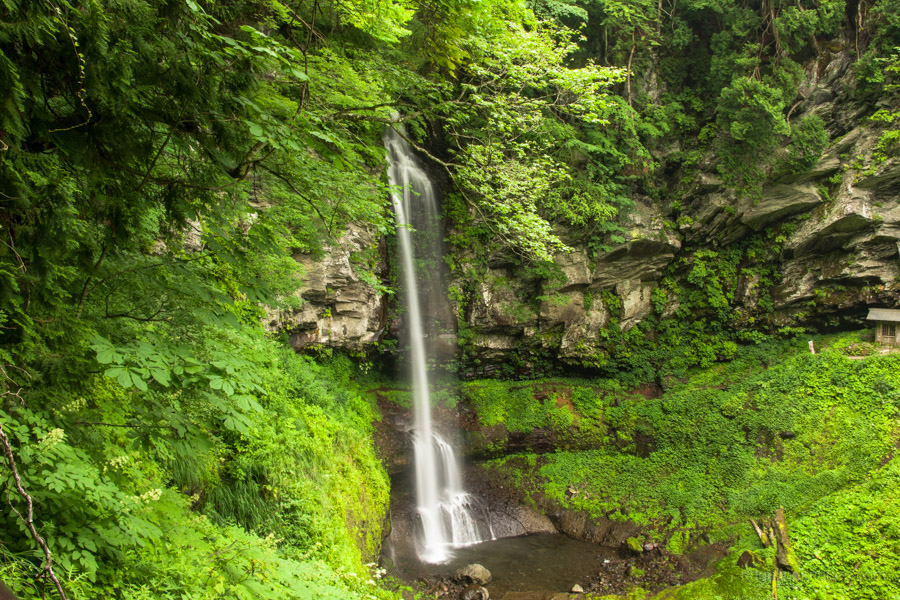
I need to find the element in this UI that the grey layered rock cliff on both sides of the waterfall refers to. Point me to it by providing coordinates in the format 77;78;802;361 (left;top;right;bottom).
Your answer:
273;44;900;374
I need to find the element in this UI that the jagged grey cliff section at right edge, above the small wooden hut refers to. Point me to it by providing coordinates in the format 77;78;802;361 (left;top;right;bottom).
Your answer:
681;47;900;326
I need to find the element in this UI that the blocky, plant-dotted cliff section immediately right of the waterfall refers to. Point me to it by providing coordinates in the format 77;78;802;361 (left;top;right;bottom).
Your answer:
451;197;681;372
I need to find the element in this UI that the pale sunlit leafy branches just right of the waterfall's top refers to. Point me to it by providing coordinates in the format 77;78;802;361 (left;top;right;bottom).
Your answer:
444;18;622;260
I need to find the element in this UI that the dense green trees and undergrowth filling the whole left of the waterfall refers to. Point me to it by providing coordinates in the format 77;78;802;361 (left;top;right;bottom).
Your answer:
0;0;426;598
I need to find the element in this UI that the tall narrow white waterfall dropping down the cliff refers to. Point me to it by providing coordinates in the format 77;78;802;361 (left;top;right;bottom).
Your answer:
384;128;482;563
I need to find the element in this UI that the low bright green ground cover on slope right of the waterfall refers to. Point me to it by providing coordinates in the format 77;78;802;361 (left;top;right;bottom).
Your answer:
465;335;900;599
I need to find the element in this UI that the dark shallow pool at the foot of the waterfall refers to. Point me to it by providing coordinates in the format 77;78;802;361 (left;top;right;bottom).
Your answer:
381;470;727;600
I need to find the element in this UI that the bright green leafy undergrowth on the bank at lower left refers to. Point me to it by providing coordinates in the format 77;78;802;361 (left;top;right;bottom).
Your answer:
0;346;395;600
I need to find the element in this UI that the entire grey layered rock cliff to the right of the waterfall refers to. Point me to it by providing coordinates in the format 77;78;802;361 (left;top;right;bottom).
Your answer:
446;39;900;374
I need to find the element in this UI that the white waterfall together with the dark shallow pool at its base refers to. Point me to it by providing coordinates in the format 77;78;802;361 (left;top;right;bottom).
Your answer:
384;129;724;598
